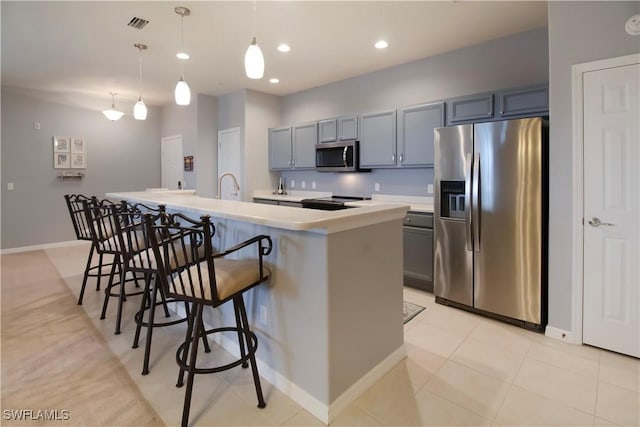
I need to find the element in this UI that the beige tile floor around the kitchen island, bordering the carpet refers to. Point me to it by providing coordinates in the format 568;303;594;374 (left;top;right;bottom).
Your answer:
1;242;640;426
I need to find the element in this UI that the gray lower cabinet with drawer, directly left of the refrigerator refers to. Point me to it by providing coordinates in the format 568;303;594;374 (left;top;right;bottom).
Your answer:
403;211;433;292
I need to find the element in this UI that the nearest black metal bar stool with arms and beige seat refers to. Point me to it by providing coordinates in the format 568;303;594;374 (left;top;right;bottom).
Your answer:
145;213;273;427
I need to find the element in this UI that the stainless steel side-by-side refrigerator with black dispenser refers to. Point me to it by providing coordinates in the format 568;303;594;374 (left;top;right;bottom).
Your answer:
434;117;552;330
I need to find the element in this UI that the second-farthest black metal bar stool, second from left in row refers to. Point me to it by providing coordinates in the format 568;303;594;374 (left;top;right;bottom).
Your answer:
82;200;144;335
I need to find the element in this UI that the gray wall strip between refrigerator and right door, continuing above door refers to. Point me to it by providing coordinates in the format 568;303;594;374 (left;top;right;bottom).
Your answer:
549;1;640;331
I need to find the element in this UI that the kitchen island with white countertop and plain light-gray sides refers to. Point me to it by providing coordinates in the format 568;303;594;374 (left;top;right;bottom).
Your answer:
107;192;409;423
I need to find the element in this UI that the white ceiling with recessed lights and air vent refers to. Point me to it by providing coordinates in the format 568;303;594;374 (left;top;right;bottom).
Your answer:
0;0;547;106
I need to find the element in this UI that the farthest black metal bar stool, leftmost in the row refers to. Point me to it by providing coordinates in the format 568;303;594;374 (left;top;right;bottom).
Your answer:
64;194;111;305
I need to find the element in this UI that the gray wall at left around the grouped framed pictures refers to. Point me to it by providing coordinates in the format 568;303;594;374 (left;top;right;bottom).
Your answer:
0;86;160;249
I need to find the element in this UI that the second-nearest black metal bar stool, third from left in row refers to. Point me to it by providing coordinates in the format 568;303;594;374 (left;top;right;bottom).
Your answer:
111;201;211;375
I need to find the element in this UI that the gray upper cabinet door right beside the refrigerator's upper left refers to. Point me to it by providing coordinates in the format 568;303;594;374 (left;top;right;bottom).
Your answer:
398;102;444;166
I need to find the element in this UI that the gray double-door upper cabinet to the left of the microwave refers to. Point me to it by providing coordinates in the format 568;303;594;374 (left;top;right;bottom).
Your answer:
269;122;318;170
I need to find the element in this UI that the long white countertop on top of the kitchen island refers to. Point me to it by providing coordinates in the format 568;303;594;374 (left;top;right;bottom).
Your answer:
106;191;409;234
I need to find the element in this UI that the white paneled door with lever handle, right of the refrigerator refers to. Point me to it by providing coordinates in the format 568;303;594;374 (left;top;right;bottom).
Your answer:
583;64;640;357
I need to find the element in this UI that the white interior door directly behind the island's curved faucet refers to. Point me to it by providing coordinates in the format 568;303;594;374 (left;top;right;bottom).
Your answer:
218;128;243;200
